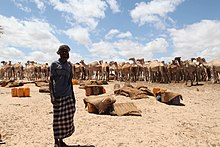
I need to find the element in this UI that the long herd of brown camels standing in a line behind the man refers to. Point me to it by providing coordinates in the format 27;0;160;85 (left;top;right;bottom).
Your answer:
0;57;220;85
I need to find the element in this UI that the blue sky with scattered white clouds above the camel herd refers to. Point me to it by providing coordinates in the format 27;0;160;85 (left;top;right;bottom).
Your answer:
0;0;220;63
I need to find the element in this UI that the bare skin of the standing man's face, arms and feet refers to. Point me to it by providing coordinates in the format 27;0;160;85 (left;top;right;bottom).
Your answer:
49;49;73;147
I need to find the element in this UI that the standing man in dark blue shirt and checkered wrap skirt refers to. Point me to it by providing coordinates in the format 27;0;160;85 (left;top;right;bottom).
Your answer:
49;45;75;147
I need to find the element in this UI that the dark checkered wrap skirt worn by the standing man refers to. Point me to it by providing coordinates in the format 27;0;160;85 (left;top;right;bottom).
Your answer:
53;96;75;139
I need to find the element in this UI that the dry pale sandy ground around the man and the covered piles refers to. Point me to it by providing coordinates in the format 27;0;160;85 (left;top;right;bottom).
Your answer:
0;82;220;147
